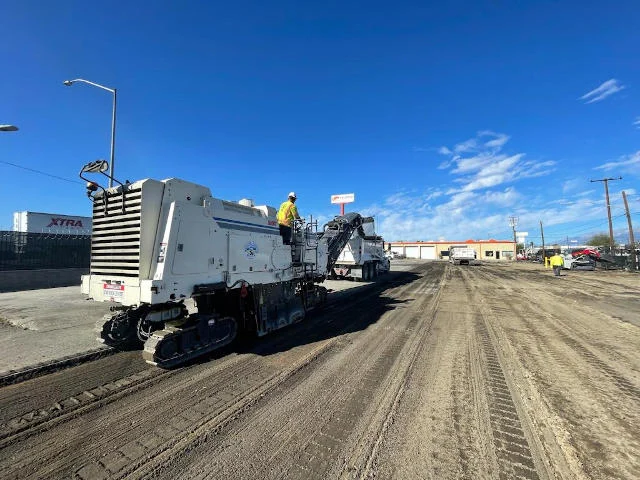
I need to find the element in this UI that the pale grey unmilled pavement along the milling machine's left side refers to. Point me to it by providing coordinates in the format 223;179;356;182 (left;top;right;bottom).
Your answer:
0;261;410;375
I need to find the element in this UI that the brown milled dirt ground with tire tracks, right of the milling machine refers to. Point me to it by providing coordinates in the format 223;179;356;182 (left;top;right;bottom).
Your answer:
0;261;640;479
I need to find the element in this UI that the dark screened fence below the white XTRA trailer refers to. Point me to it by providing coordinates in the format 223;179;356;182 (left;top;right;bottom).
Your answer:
0;231;91;271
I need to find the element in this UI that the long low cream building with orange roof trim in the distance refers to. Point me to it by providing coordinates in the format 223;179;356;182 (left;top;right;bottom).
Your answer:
387;238;516;261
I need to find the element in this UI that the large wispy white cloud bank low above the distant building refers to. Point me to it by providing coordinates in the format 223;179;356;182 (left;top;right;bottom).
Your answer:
361;131;640;244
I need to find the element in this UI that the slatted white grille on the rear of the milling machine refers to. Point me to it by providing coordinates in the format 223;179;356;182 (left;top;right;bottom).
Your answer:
91;187;142;277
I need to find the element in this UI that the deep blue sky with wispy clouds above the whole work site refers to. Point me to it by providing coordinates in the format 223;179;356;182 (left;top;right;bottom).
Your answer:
0;0;640;243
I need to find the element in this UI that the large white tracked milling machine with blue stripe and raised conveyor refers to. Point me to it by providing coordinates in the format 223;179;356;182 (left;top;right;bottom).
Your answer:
80;161;361;367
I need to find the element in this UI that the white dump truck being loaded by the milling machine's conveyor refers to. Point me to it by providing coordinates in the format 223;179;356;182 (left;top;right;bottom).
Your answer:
330;217;390;281
